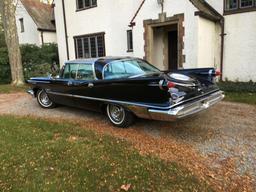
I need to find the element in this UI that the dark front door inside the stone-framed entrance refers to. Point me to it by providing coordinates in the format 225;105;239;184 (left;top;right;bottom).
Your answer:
168;31;178;71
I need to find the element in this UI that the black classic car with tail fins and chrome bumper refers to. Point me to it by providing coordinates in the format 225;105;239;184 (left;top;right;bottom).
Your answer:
28;57;224;127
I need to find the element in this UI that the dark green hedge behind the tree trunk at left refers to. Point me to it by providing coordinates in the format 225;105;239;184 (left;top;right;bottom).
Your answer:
0;44;59;83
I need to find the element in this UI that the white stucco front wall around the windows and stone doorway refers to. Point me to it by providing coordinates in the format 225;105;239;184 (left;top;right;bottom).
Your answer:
55;0;201;68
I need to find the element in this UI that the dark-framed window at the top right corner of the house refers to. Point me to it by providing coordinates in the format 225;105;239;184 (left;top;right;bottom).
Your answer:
225;0;256;14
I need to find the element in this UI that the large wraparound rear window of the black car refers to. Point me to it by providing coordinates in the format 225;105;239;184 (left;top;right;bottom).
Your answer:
103;59;160;79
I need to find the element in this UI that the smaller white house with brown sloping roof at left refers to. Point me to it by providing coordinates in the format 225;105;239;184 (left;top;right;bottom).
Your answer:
16;0;57;46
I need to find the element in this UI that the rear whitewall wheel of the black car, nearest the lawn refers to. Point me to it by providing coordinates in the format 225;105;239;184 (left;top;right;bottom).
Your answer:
107;104;135;128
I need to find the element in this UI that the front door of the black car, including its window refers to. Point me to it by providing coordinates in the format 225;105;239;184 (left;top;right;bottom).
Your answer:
47;63;79;106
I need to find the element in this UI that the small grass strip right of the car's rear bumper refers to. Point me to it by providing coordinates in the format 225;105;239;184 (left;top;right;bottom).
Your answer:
225;92;256;105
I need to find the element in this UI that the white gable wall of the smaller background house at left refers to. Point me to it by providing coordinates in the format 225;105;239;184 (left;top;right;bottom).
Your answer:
16;1;40;45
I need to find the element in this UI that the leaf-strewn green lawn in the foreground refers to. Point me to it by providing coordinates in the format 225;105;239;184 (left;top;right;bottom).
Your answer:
0;116;212;192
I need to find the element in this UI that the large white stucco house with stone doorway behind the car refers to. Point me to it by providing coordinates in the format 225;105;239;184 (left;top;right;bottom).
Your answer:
54;0;256;81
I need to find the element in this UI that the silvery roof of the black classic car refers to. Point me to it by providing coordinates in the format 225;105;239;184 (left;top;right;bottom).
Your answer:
65;56;140;64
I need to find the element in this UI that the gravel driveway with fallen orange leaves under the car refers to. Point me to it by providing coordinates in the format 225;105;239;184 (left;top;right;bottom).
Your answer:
0;93;256;191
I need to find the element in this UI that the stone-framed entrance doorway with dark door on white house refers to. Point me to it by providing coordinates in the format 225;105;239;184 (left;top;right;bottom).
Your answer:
143;13;185;71
